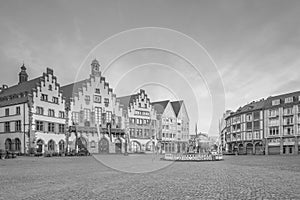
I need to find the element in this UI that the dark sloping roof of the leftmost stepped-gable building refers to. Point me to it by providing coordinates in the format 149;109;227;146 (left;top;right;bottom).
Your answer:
0;77;41;98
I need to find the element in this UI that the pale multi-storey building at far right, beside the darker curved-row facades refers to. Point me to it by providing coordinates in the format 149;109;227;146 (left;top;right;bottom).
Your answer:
264;91;300;154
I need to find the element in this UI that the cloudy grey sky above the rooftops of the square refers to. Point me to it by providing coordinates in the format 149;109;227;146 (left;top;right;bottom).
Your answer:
0;0;300;135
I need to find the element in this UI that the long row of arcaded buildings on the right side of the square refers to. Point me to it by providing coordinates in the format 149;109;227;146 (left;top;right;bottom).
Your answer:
220;91;300;155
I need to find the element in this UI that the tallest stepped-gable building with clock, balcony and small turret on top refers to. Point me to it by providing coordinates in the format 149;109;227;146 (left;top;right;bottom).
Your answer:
62;59;125;153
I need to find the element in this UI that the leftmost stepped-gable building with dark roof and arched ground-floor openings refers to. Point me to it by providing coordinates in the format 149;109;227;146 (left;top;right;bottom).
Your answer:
0;64;66;153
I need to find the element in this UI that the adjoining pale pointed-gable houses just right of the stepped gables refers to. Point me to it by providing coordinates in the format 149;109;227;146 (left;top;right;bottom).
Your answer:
151;100;189;152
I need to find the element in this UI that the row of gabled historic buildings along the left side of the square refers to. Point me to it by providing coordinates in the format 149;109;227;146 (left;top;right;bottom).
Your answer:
0;60;189;153
